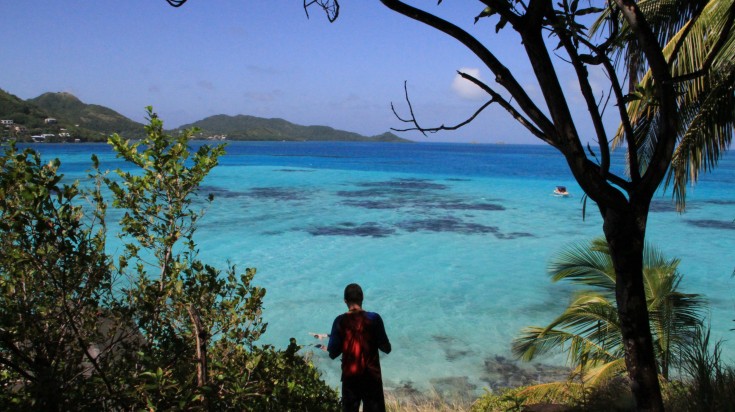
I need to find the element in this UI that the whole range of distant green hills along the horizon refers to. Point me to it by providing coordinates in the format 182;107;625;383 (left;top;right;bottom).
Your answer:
0;89;411;143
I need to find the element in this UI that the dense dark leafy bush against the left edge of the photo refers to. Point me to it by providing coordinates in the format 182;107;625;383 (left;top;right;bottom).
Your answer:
0;145;115;410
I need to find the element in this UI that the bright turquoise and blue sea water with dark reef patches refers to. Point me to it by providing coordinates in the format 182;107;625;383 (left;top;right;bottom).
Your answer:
20;142;735;394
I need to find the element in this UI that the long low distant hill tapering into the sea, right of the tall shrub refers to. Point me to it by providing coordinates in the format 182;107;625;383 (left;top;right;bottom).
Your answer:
181;114;409;142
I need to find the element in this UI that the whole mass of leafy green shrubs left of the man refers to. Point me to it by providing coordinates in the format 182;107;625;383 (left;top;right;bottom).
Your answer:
0;111;338;411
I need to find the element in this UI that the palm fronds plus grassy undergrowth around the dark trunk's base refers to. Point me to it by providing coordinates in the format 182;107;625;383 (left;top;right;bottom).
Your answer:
458;238;735;412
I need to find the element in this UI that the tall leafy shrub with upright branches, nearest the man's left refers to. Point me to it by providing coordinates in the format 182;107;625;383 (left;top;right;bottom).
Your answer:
105;108;336;411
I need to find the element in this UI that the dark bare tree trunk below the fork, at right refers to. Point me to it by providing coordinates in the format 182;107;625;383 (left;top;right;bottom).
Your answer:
603;205;664;411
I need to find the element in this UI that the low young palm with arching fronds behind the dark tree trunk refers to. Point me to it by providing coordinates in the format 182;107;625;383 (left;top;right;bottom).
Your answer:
513;238;705;385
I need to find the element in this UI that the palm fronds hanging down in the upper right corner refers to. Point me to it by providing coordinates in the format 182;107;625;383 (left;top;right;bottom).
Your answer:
593;0;735;209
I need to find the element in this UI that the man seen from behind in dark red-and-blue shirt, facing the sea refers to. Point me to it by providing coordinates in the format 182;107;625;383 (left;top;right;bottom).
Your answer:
327;283;391;412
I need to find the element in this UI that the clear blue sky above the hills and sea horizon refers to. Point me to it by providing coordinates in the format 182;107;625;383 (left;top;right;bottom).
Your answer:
0;0;613;144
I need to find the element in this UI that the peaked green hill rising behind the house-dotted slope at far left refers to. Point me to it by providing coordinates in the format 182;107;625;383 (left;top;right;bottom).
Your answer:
28;92;144;139
